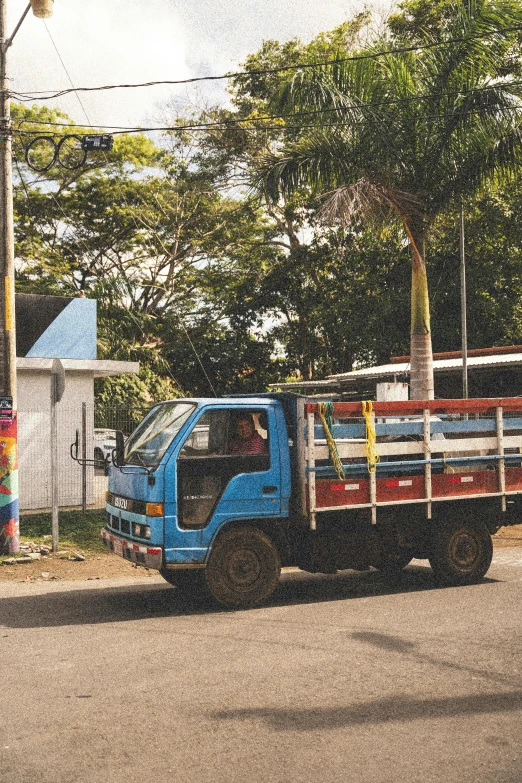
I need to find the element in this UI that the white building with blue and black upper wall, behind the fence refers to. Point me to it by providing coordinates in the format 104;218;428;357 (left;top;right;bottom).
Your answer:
16;294;139;511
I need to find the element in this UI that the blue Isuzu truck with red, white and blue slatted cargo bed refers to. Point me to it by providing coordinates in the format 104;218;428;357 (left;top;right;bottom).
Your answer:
102;393;522;608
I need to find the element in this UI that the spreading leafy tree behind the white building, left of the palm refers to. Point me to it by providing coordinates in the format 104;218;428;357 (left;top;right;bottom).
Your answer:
16;105;288;402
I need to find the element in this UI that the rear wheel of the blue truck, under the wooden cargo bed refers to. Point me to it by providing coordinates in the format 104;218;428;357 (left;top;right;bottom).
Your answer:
429;518;493;586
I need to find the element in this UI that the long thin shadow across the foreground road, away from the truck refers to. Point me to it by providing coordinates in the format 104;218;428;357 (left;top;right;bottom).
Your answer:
211;691;522;732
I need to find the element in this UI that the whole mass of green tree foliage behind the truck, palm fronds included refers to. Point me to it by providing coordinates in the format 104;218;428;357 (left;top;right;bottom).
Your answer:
13;6;522;402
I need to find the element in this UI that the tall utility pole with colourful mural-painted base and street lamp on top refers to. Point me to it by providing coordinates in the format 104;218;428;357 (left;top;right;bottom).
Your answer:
0;0;53;553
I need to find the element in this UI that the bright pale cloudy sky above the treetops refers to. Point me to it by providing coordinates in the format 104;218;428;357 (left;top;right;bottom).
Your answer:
7;0;390;128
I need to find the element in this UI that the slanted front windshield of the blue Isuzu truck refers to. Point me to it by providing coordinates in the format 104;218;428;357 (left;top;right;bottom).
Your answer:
125;402;196;468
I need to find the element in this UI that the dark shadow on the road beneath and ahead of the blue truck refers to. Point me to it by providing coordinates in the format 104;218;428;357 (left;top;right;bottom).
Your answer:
0;566;493;636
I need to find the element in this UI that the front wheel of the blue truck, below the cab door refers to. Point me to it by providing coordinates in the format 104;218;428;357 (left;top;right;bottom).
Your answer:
204;527;281;609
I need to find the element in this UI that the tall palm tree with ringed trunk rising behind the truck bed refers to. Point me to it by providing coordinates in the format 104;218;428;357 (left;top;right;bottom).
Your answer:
256;0;522;399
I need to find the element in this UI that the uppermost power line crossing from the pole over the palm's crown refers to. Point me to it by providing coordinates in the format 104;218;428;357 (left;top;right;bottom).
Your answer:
10;25;522;103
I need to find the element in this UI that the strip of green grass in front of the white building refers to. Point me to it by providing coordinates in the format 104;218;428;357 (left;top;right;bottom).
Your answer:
20;509;106;555
